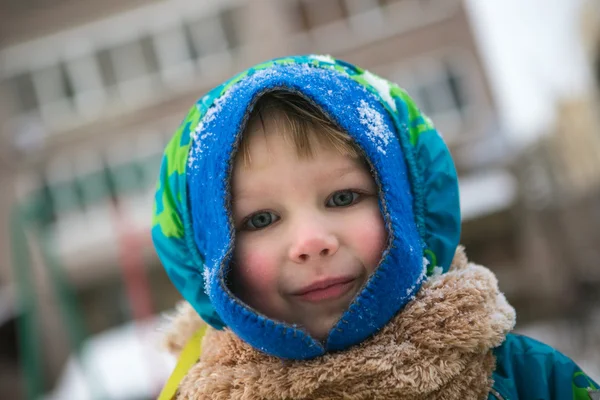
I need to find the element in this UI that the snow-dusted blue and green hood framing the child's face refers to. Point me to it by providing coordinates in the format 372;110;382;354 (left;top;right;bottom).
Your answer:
152;56;460;359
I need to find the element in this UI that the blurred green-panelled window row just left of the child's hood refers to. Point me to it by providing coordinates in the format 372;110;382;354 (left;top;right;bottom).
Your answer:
35;131;164;230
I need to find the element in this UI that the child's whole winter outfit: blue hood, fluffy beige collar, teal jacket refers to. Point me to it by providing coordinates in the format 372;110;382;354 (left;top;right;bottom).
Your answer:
152;55;597;400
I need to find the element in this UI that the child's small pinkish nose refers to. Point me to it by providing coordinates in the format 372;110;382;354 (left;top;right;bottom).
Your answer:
289;230;339;263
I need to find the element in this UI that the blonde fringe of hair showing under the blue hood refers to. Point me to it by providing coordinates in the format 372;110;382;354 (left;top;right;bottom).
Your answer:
238;90;362;165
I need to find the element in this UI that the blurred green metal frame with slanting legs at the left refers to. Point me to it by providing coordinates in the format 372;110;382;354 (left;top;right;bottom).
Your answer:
10;154;162;400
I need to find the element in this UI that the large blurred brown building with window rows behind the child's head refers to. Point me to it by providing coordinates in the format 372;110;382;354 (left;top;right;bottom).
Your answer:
0;0;578;396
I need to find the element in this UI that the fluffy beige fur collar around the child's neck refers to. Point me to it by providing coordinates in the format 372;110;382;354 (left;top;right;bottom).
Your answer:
168;248;515;400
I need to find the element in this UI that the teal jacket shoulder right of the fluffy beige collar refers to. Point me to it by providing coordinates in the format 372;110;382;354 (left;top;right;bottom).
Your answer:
488;334;600;400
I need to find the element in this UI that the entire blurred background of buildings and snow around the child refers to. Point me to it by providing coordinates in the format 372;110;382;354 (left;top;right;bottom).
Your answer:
0;0;600;400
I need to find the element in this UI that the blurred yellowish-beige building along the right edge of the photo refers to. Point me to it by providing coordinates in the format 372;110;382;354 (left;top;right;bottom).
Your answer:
515;0;600;324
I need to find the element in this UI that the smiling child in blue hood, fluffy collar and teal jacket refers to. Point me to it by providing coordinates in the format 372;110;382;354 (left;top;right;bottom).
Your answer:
152;56;597;400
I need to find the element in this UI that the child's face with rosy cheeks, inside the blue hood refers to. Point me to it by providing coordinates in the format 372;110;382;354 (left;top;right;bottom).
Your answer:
232;115;387;340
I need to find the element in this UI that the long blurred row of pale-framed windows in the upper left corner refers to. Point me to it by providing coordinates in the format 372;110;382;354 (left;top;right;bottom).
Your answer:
7;0;244;129
